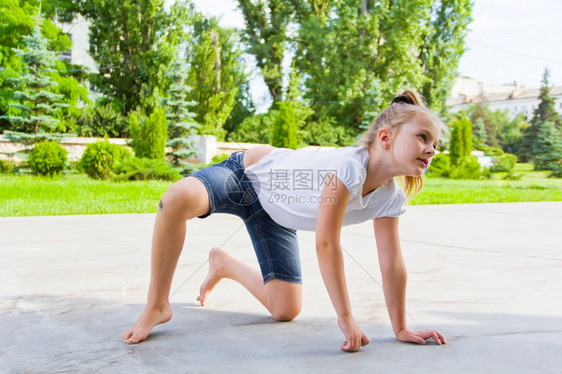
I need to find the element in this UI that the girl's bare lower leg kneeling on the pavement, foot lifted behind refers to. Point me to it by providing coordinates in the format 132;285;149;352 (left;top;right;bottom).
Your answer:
197;248;302;321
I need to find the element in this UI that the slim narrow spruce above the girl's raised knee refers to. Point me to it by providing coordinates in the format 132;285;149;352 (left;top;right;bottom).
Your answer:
163;58;199;172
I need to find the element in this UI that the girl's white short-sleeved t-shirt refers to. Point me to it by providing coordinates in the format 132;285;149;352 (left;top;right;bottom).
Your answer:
246;147;406;231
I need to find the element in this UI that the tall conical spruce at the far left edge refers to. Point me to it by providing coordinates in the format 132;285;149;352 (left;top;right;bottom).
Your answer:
2;8;68;143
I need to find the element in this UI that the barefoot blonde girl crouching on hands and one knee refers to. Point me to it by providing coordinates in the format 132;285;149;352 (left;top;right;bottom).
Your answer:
122;91;446;352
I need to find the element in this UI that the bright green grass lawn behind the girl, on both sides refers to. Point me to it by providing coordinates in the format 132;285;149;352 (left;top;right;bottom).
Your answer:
0;164;562;217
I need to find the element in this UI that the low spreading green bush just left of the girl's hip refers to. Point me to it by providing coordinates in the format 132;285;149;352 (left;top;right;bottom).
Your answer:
113;157;182;182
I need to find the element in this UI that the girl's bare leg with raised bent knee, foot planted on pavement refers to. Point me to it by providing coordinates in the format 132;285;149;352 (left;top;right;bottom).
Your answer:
122;177;209;343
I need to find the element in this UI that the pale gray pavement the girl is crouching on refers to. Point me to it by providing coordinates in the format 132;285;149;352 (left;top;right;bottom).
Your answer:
0;202;562;374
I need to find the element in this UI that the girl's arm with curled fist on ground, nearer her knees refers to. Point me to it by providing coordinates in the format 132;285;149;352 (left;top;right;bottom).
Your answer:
316;176;370;352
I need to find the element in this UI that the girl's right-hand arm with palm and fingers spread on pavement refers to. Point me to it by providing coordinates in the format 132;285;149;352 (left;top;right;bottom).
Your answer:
374;218;446;344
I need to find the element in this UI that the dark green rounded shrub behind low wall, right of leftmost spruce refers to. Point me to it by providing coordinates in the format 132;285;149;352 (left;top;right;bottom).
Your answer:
75;103;129;138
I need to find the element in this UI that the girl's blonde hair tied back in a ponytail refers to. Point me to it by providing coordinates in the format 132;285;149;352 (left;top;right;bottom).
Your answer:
359;90;447;197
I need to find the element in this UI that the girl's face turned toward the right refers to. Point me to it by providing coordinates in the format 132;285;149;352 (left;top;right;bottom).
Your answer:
389;116;440;177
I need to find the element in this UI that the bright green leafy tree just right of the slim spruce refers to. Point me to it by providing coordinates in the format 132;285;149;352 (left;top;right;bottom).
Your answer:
188;15;247;140
